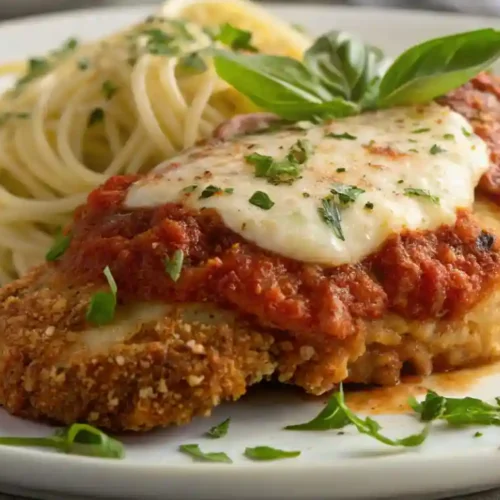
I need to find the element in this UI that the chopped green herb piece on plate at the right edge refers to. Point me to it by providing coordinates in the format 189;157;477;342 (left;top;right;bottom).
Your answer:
412;391;500;426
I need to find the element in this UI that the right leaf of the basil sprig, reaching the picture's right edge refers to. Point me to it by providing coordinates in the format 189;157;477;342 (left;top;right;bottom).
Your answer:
378;29;500;108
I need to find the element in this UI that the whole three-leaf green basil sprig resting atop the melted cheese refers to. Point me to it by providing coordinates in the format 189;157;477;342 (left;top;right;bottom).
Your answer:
214;29;500;120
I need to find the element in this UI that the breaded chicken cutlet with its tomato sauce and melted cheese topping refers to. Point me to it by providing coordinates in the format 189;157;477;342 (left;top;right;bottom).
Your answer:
0;75;500;430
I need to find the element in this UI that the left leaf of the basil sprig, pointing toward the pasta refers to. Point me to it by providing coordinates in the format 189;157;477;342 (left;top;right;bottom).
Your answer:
214;50;359;121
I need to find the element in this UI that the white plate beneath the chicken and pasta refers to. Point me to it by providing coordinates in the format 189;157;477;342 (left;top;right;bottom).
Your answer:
0;6;500;500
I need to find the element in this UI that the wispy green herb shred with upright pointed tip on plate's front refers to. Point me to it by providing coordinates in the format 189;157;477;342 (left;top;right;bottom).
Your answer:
285;385;429;447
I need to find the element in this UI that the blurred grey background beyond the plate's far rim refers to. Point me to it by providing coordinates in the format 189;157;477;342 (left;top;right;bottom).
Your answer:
0;0;500;20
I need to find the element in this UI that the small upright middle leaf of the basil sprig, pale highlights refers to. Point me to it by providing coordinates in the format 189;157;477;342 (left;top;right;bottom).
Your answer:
304;31;388;102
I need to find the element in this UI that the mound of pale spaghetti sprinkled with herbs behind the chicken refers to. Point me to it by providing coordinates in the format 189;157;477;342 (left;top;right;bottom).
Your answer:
0;18;254;284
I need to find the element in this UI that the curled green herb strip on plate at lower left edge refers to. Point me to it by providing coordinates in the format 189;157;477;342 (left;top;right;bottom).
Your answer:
0;424;125;458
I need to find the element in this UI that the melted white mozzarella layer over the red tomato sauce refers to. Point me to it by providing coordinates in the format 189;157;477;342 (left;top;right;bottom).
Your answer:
125;104;489;266
